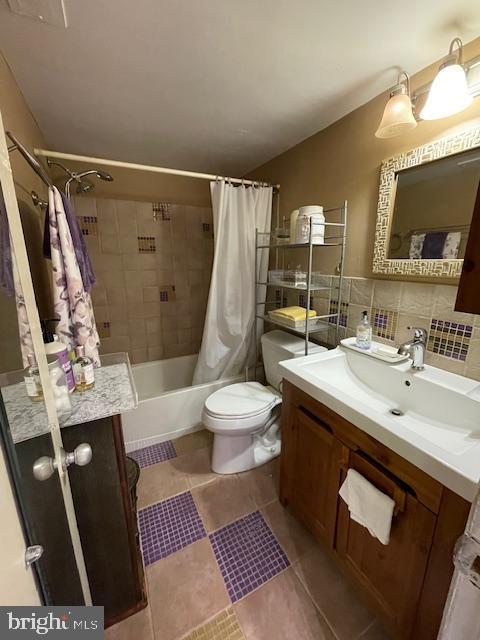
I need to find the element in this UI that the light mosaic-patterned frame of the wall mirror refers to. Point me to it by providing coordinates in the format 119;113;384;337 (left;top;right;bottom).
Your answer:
373;127;480;279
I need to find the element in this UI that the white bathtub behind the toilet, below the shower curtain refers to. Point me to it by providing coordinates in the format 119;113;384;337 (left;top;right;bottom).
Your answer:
122;355;243;453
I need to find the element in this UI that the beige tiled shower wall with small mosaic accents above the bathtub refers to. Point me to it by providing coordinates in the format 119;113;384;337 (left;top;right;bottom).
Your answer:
74;196;213;362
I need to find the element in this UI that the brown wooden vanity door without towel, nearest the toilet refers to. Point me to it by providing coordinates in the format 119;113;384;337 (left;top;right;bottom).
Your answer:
281;407;349;547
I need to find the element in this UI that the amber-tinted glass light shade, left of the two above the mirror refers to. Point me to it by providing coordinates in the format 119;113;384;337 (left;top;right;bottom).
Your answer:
375;71;417;138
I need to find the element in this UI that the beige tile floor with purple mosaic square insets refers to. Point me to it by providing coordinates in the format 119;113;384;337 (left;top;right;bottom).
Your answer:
106;431;388;640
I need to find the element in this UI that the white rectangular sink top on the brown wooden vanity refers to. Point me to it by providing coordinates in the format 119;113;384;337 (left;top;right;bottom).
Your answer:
280;347;480;500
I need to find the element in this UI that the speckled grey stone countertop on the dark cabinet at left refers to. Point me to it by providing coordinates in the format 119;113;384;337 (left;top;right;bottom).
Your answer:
1;354;138;442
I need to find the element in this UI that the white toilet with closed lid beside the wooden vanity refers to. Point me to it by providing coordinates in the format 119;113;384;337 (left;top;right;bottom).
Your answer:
202;330;326;474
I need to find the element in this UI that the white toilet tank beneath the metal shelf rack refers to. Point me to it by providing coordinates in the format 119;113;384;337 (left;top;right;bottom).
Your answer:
261;329;327;390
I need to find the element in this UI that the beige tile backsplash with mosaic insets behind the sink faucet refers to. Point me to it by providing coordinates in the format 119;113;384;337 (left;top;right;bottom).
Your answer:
272;276;480;380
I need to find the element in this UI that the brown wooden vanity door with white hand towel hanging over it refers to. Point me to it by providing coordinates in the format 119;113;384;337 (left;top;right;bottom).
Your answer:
336;453;436;639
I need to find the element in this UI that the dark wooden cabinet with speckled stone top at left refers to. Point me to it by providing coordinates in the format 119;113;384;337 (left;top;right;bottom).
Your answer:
0;354;147;627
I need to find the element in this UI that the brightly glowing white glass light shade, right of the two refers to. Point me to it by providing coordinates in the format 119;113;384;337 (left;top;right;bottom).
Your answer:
420;64;473;120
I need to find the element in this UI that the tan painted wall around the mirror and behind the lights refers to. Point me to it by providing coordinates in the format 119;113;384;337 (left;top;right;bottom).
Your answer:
249;38;480;277
